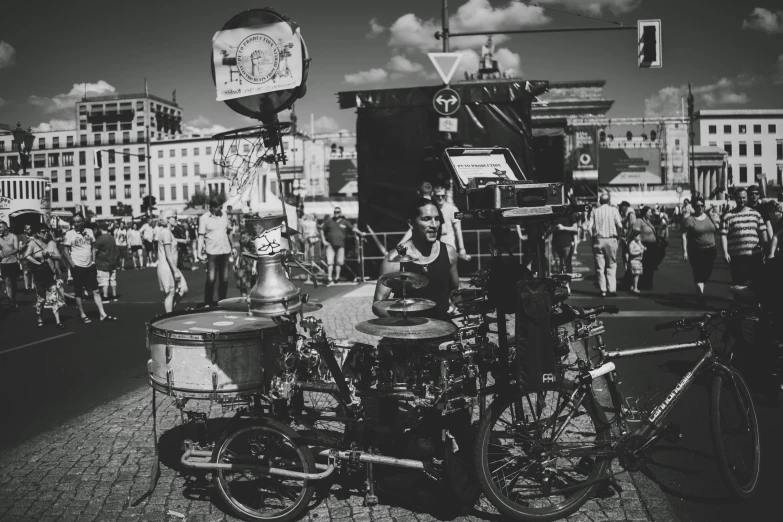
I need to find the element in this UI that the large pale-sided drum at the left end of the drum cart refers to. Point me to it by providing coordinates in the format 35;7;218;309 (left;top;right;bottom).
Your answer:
147;309;293;400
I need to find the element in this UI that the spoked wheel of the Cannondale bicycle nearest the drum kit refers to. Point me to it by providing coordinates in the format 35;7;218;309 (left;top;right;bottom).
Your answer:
475;382;611;522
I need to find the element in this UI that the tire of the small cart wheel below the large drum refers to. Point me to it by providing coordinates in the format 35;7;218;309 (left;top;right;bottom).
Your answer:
212;418;316;522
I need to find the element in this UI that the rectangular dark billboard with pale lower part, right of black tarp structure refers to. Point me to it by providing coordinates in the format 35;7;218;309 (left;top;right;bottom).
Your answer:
598;148;663;185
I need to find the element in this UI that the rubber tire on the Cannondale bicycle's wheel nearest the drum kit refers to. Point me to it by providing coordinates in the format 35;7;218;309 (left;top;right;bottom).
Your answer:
475;382;612;522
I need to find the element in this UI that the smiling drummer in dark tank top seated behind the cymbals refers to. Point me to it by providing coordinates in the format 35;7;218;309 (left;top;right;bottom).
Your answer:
373;198;459;319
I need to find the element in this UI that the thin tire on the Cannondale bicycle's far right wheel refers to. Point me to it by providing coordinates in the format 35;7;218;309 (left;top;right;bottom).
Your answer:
710;368;761;499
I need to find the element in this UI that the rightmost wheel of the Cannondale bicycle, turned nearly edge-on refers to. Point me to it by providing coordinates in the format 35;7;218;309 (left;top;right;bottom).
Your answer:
710;368;761;499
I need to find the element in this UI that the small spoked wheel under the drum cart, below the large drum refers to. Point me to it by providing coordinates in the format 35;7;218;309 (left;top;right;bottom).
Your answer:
212;418;316;522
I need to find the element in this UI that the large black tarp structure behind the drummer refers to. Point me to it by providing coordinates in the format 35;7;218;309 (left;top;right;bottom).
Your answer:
338;80;548;232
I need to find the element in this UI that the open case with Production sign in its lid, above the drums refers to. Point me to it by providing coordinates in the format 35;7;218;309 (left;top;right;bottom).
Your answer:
443;147;565;211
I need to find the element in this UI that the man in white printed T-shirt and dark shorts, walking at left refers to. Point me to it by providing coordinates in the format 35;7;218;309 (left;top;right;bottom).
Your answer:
63;215;117;323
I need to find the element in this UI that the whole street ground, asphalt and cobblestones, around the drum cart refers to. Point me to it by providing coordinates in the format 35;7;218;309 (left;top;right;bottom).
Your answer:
0;237;783;521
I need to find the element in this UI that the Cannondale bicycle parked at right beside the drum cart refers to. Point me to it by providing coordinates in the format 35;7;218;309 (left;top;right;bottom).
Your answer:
475;306;761;522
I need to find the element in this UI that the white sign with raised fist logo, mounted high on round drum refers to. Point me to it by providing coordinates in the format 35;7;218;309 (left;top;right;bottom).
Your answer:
212;22;302;101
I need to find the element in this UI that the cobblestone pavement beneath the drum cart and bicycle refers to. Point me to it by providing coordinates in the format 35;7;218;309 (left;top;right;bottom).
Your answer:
0;287;673;522
